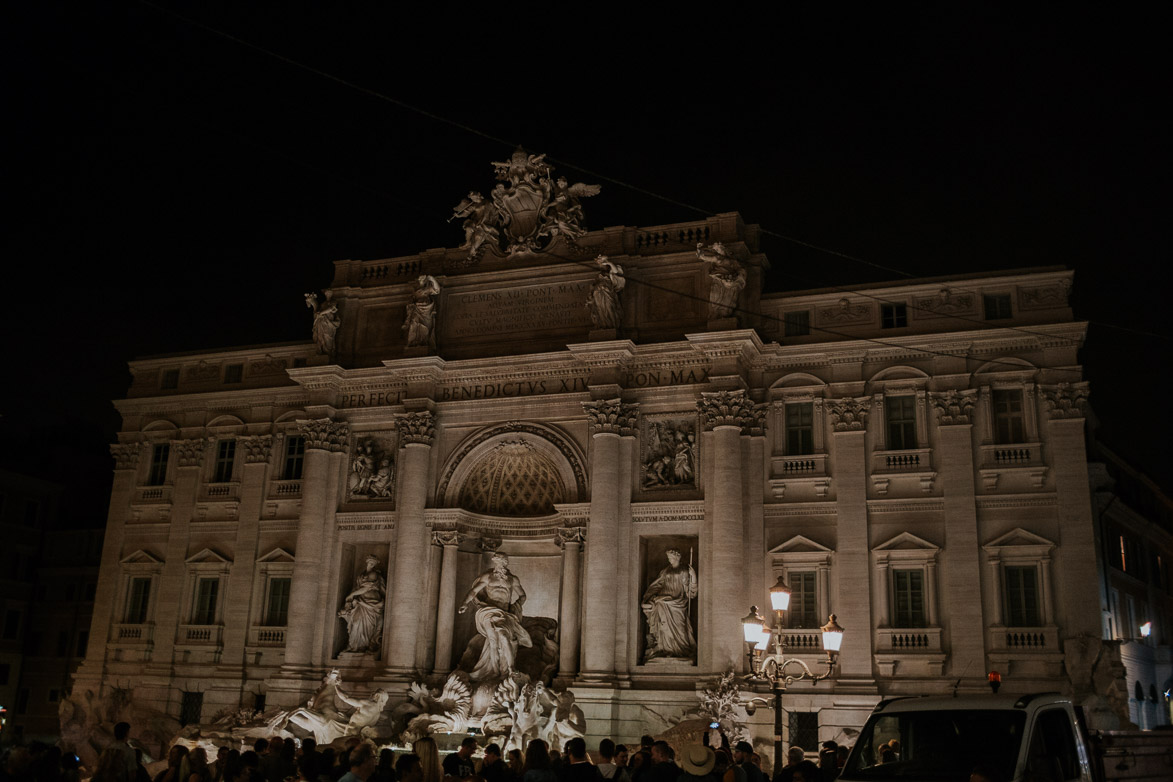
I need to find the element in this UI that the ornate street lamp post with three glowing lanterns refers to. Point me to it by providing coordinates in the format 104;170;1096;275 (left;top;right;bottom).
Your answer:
741;577;843;774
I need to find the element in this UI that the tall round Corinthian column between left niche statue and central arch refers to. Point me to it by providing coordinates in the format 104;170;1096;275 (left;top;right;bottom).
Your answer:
384;410;436;681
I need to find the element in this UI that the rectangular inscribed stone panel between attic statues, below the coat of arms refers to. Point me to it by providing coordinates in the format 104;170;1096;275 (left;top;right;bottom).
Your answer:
443;280;590;339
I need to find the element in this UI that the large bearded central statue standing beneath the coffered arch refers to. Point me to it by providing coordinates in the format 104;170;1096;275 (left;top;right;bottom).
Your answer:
457;552;534;681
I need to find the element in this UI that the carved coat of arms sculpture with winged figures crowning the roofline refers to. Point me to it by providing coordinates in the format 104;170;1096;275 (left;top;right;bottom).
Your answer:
448;148;599;264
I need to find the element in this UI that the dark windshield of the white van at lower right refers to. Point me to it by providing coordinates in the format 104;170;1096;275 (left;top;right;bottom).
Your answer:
840;709;1026;782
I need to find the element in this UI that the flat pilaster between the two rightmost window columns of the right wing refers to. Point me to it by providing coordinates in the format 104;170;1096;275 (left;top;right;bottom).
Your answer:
925;390;994;678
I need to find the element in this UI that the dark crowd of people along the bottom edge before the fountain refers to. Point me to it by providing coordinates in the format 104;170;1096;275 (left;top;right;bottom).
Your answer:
0;722;847;782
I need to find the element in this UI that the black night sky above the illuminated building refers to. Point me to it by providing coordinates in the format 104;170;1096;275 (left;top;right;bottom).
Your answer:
0;0;1173;512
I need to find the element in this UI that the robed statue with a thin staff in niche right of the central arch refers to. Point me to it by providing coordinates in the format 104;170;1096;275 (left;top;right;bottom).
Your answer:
639;549;697;662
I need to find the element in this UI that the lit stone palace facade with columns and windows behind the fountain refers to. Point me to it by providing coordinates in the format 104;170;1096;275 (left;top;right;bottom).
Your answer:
75;164;1100;759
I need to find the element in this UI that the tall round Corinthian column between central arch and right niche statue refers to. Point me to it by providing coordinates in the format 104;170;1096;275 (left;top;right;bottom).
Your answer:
577;399;626;681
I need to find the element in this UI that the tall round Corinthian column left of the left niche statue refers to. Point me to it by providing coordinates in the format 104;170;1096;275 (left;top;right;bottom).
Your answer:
285;419;350;669
